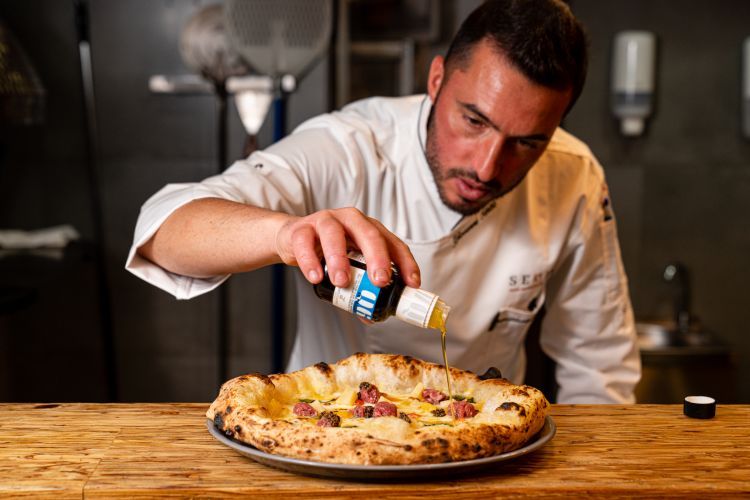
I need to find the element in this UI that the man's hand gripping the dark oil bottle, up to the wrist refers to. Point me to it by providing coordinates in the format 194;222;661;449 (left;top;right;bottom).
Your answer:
276;208;421;288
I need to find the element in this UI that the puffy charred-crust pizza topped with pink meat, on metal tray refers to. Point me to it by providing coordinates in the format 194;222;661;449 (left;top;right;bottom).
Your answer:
206;353;549;465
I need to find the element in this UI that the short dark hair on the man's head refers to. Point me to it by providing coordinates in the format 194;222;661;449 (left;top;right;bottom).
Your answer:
445;0;588;113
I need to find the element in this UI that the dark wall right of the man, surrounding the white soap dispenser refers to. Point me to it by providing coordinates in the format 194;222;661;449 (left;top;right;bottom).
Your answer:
565;0;750;401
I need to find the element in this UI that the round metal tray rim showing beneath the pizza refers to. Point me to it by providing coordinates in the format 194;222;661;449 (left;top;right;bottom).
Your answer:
206;416;557;480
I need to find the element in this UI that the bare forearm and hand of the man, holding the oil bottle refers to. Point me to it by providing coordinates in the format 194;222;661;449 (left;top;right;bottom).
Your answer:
138;198;420;287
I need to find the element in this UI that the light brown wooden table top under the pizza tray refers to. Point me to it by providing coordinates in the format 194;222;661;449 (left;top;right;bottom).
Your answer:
0;404;750;499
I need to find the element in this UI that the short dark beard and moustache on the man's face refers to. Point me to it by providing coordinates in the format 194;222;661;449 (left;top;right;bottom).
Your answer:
425;106;512;215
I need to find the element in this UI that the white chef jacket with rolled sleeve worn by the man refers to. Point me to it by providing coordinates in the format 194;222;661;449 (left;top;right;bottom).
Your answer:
126;96;640;403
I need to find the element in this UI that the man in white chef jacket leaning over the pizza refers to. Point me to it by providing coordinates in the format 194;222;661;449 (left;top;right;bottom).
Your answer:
128;0;640;403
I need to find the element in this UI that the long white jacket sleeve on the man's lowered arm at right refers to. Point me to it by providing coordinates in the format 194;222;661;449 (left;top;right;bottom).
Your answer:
541;181;641;403
